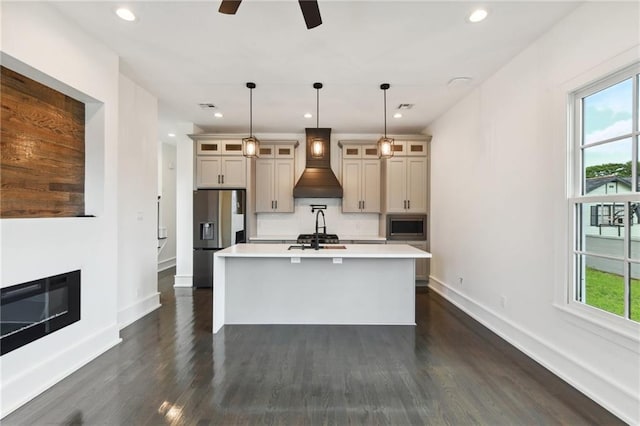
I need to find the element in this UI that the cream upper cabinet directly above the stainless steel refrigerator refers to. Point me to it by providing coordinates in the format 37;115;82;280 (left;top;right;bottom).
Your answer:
191;135;247;188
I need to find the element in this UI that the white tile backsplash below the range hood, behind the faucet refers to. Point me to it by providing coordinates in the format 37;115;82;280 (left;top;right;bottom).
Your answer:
257;198;380;238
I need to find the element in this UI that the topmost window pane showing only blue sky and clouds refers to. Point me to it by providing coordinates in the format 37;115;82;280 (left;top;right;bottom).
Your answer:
582;78;633;144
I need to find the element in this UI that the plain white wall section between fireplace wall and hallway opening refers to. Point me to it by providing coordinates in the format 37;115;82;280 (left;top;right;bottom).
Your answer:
118;75;160;328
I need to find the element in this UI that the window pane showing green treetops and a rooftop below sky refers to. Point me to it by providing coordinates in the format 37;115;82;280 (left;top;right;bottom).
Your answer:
582;139;632;195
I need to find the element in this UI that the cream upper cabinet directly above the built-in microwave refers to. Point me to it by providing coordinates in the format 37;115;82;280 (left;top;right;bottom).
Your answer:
385;141;428;213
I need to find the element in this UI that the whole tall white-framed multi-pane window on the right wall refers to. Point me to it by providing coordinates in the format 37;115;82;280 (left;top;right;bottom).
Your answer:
569;64;640;322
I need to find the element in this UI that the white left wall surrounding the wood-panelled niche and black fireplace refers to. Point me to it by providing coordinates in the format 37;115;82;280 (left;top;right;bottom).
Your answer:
0;2;119;417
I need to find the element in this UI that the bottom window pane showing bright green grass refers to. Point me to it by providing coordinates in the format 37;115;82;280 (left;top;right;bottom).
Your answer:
576;255;624;316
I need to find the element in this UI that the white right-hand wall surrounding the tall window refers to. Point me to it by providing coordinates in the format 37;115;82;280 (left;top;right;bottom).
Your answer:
427;2;640;424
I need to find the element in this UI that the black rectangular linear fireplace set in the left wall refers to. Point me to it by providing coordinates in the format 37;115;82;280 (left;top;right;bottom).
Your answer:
0;270;80;355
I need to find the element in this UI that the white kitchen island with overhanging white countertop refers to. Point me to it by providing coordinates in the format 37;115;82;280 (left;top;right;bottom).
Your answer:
213;244;431;333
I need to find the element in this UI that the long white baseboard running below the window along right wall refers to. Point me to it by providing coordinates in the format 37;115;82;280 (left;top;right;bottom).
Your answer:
429;276;640;424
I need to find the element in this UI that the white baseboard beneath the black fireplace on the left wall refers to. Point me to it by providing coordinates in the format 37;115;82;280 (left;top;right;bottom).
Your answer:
0;324;122;418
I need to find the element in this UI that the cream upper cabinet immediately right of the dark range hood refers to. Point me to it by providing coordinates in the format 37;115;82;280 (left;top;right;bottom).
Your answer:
339;141;381;213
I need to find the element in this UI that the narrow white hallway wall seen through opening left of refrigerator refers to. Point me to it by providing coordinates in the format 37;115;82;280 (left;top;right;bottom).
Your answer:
158;143;177;271
